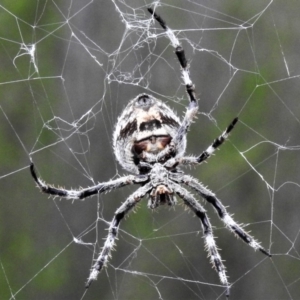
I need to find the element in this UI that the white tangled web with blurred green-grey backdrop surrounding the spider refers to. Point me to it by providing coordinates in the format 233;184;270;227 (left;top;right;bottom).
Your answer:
0;0;300;299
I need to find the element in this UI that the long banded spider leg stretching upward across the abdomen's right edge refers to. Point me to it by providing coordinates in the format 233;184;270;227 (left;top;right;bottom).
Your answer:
148;8;198;161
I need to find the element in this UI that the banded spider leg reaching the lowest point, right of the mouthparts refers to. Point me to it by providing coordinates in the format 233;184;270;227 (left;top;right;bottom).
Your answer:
170;183;229;296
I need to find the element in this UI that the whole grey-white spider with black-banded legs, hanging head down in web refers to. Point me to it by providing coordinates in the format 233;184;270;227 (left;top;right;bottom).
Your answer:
30;8;271;296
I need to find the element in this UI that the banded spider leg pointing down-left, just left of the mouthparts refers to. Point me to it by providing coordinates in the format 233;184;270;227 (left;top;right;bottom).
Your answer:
85;183;152;288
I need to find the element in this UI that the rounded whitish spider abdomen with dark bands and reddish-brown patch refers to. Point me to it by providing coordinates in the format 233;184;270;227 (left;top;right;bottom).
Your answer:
113;94;186;173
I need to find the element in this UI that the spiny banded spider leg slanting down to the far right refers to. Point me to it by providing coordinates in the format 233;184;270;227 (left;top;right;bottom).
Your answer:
172;175;272;257
